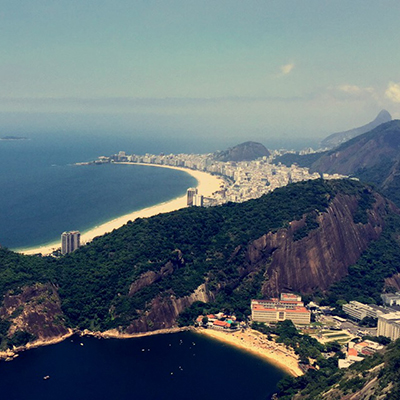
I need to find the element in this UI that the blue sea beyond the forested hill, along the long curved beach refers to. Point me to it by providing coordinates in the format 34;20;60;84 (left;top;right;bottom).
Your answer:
0;134;196;249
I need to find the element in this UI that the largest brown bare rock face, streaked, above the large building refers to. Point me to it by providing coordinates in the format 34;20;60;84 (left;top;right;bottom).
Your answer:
247;195;387;296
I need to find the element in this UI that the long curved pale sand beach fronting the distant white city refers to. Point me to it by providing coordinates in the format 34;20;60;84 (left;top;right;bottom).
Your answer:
17;163;223;255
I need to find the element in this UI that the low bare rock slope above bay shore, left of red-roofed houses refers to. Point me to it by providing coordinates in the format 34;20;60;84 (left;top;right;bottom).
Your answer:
125;284;214;333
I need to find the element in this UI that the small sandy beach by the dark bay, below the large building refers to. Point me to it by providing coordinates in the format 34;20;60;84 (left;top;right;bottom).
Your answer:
194;328;303;376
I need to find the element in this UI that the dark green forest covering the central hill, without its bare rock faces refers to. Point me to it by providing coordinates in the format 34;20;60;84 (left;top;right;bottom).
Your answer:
0;179;390;338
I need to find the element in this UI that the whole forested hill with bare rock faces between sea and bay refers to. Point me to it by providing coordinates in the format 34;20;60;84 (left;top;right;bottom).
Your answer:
0;180;400;345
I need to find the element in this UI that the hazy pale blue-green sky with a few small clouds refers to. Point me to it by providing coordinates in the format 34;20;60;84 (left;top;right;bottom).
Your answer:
0;0;400;147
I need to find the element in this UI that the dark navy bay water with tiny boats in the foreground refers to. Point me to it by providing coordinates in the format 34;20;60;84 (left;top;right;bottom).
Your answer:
0;332;284;400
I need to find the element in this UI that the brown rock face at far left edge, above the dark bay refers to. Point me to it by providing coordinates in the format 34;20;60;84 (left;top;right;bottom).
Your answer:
0;284;68;340
